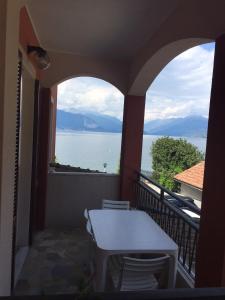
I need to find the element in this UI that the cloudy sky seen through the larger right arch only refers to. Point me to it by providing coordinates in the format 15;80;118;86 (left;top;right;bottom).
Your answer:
145;46;214;120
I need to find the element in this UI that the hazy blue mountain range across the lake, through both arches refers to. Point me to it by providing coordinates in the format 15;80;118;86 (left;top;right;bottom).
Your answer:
57;110;208;137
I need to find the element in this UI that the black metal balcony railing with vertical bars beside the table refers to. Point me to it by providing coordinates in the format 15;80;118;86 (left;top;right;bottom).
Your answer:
135;173;200;279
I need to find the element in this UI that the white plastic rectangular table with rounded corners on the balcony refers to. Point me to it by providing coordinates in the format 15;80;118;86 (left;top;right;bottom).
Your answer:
89;209;178;291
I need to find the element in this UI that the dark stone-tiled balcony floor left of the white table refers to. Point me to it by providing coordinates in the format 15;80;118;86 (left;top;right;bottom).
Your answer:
14;229;92;295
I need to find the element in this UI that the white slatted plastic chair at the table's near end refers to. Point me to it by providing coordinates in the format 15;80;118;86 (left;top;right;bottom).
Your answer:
109;255;170;291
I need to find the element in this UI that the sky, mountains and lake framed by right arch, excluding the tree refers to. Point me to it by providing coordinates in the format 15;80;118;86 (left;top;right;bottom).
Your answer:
142;43;214;196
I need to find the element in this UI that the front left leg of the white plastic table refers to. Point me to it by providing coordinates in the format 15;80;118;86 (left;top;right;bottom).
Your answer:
95;249;108;292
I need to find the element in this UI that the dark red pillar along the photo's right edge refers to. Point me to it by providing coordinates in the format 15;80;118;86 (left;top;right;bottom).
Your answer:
196;35;225;287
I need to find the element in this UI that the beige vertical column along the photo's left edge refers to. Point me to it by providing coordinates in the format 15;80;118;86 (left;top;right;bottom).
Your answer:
0;0;19;296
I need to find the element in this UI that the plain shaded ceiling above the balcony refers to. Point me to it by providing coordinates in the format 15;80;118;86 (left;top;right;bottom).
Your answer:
27;0;183;60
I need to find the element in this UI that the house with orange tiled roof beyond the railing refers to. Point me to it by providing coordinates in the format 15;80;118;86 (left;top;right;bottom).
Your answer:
174;161;205;207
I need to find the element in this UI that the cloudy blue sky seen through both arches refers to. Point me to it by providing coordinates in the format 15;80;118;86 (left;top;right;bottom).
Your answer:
58;43;214;121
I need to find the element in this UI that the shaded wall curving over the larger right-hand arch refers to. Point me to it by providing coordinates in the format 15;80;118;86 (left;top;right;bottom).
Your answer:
128;0;225;95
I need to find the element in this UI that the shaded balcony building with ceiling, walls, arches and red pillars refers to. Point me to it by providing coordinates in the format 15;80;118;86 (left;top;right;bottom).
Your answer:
0;0;225;296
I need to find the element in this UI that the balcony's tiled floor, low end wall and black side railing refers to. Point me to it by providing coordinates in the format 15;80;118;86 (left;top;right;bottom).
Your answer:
15;172;200;295
